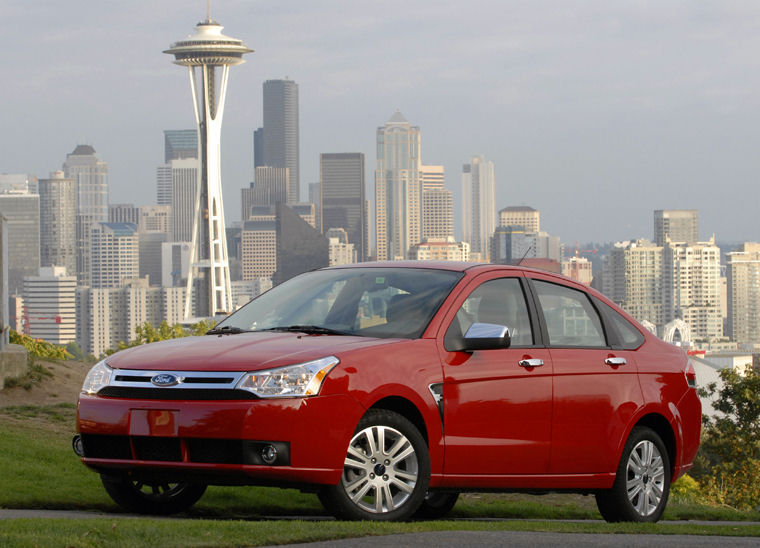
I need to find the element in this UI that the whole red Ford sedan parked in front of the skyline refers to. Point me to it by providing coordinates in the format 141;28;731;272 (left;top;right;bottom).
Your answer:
74;262;701;521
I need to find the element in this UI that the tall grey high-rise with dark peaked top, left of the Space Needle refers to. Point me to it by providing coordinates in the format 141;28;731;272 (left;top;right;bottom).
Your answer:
63;145;108;285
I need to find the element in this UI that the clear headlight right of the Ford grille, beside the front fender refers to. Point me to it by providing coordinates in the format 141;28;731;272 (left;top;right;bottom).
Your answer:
236;356;340;398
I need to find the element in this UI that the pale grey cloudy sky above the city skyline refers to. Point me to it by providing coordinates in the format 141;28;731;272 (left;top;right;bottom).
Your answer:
0;0;760;242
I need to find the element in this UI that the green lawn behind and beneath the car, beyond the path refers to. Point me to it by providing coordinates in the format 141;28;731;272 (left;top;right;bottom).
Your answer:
0;404;760;532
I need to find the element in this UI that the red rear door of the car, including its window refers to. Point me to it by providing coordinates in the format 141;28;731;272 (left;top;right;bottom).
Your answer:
531;274;642;474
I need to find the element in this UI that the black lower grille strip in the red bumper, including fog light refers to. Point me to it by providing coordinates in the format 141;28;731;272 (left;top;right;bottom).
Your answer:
82;434;290;466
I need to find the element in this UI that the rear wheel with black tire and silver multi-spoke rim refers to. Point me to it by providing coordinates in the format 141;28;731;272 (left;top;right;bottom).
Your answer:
596;426;670;522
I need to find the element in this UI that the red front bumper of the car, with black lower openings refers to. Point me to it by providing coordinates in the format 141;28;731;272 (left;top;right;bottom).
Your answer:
77;394;364;485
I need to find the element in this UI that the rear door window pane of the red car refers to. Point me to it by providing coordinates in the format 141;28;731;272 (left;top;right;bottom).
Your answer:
533;280;607;348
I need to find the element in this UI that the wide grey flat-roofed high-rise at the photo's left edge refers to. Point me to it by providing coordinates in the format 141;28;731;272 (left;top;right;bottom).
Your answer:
0;192;40;295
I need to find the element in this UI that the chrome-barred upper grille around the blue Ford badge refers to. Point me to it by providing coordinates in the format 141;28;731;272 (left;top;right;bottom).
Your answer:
108;369;246;390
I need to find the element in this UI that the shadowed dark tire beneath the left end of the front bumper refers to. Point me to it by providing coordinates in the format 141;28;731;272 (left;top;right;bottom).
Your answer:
100;475;206;515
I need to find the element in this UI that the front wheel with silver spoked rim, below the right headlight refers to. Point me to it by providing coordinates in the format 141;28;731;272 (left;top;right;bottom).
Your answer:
318;409;430;521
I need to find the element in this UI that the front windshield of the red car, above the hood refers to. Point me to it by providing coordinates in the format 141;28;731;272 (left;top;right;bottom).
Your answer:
214;268;463;338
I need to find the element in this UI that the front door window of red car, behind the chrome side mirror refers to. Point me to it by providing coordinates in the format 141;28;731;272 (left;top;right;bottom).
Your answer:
446;278;533;347
